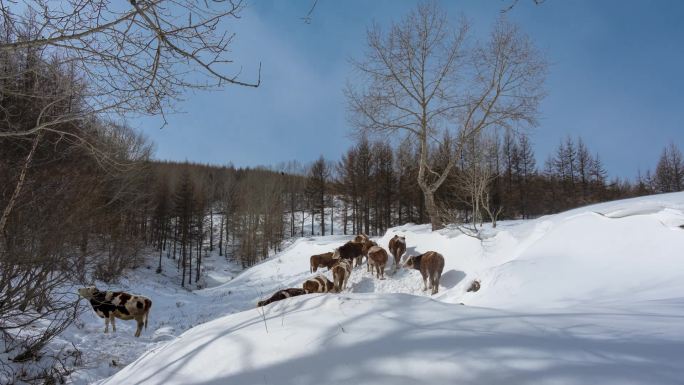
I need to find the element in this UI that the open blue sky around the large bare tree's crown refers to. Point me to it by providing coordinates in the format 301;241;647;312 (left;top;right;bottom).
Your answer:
130;0;684;178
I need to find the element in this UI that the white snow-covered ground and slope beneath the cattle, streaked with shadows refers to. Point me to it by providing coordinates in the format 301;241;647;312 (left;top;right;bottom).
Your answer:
64;193;684;385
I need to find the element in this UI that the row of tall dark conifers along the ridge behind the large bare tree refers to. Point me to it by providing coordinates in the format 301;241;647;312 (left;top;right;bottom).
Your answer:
312;131;684;235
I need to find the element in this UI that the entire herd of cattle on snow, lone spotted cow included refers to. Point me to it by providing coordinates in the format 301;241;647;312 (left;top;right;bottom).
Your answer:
78;234;446;337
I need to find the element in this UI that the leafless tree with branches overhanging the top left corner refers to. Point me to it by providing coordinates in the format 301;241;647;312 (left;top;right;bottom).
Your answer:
0;0;261;232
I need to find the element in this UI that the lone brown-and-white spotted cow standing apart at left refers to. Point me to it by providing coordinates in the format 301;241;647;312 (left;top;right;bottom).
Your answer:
78;286;152;337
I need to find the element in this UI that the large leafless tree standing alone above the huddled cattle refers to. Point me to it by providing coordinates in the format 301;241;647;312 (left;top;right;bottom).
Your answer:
345;3;546;229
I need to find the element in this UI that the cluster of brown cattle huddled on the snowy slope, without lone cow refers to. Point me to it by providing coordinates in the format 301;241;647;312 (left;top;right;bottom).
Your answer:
257;234;444;307
